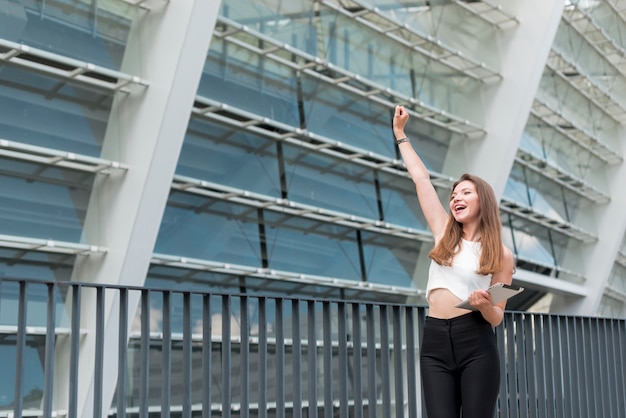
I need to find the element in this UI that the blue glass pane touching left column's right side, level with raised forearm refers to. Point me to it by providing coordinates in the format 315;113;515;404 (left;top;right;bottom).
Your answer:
176;119;280;197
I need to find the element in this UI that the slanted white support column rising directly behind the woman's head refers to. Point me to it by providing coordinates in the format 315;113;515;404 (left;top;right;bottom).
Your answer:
444;0;564;198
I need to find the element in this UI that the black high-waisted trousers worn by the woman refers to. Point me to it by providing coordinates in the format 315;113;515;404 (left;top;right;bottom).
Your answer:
420;312;500;418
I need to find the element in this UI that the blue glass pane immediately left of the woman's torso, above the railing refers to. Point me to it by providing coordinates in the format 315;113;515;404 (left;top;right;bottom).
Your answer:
362;232;422;288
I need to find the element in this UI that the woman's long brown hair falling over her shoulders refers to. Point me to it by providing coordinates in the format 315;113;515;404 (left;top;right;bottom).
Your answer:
428;174;504;274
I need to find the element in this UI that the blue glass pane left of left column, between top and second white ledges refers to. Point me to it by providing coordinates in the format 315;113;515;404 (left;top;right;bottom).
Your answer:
0;66;112;157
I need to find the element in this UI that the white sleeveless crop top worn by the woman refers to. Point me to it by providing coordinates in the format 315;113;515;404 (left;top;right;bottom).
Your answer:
426;240;491;300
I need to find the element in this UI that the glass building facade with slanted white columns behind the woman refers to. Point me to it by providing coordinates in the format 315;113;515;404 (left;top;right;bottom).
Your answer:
0;0;626;410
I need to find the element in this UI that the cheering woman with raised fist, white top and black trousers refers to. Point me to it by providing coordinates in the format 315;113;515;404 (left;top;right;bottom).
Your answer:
393;106;515;418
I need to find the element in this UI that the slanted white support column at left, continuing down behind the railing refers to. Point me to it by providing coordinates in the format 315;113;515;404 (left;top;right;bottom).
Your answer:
55;0;221;418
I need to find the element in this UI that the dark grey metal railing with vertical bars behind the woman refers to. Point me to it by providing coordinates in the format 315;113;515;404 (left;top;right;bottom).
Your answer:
0;279;626;418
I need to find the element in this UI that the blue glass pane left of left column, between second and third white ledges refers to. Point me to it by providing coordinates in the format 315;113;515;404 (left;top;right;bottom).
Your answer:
0;169;92;242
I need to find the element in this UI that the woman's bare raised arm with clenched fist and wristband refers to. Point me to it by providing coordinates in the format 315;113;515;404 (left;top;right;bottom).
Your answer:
393;106;448;240
